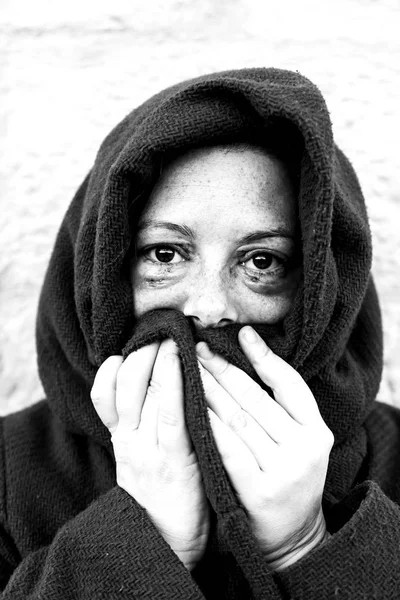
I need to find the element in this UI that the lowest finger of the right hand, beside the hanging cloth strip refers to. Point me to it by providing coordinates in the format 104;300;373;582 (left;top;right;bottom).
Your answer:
208;409;261;496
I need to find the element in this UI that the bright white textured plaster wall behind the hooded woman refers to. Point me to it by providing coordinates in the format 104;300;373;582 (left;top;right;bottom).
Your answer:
0;0;400;413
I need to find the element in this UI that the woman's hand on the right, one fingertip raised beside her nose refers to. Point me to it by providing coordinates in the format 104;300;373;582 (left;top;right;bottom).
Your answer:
197;326;334;569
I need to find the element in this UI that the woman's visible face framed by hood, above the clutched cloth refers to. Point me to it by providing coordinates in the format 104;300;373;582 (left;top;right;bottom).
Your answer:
132;146;301;328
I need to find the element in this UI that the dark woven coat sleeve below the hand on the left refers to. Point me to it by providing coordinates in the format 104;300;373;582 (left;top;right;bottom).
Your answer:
0;487;203;600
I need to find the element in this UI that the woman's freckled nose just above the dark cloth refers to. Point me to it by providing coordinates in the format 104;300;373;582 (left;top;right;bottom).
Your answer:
183;273;238;328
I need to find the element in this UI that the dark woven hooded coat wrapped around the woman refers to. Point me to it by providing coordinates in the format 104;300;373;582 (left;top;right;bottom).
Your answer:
0;69;400;600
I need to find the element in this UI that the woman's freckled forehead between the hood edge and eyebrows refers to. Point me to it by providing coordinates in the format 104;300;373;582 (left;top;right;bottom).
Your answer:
142;146;296;227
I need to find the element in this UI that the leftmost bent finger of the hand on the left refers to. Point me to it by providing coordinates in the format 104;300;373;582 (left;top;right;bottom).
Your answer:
90;356;122;434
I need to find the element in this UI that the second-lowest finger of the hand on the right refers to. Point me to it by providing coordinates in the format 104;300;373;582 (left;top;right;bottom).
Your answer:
200;368;278;470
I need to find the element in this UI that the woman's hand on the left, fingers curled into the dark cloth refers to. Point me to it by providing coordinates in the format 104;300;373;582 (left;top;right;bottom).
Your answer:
91;340;209;570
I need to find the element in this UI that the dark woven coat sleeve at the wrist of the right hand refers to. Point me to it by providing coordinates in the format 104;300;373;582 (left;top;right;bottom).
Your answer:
274;481;400;600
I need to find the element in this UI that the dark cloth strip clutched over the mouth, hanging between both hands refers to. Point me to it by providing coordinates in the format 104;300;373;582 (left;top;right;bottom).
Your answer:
123;309;271;597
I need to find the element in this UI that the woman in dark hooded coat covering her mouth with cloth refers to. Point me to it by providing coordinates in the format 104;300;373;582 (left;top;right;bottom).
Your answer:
0;69;400;599
